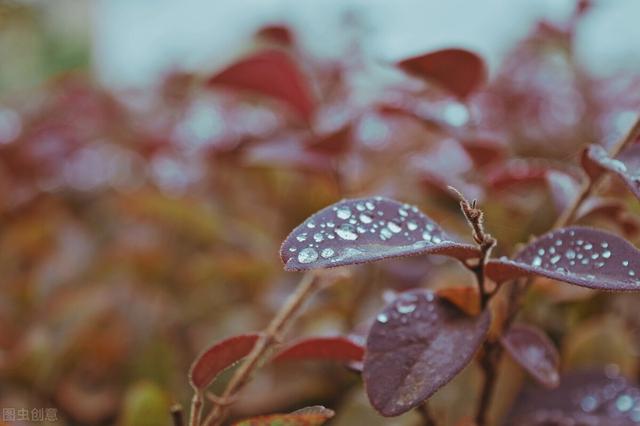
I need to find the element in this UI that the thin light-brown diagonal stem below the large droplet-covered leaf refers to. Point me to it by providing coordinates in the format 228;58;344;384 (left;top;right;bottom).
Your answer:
203;272;318;426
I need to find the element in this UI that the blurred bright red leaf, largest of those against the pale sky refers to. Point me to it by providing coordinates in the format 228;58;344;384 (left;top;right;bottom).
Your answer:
208;49;315;121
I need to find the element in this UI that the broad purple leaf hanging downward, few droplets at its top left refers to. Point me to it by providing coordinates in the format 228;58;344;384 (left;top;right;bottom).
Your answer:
363;290;490;416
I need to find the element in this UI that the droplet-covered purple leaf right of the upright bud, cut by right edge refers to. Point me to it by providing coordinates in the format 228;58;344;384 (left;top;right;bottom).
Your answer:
486;226;640;291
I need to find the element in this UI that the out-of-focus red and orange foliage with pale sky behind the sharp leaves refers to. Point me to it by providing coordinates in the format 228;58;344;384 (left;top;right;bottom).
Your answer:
0;0;640;425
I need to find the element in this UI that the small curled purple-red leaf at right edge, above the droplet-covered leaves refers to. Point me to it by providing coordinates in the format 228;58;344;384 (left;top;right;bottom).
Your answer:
582;145;640;199
